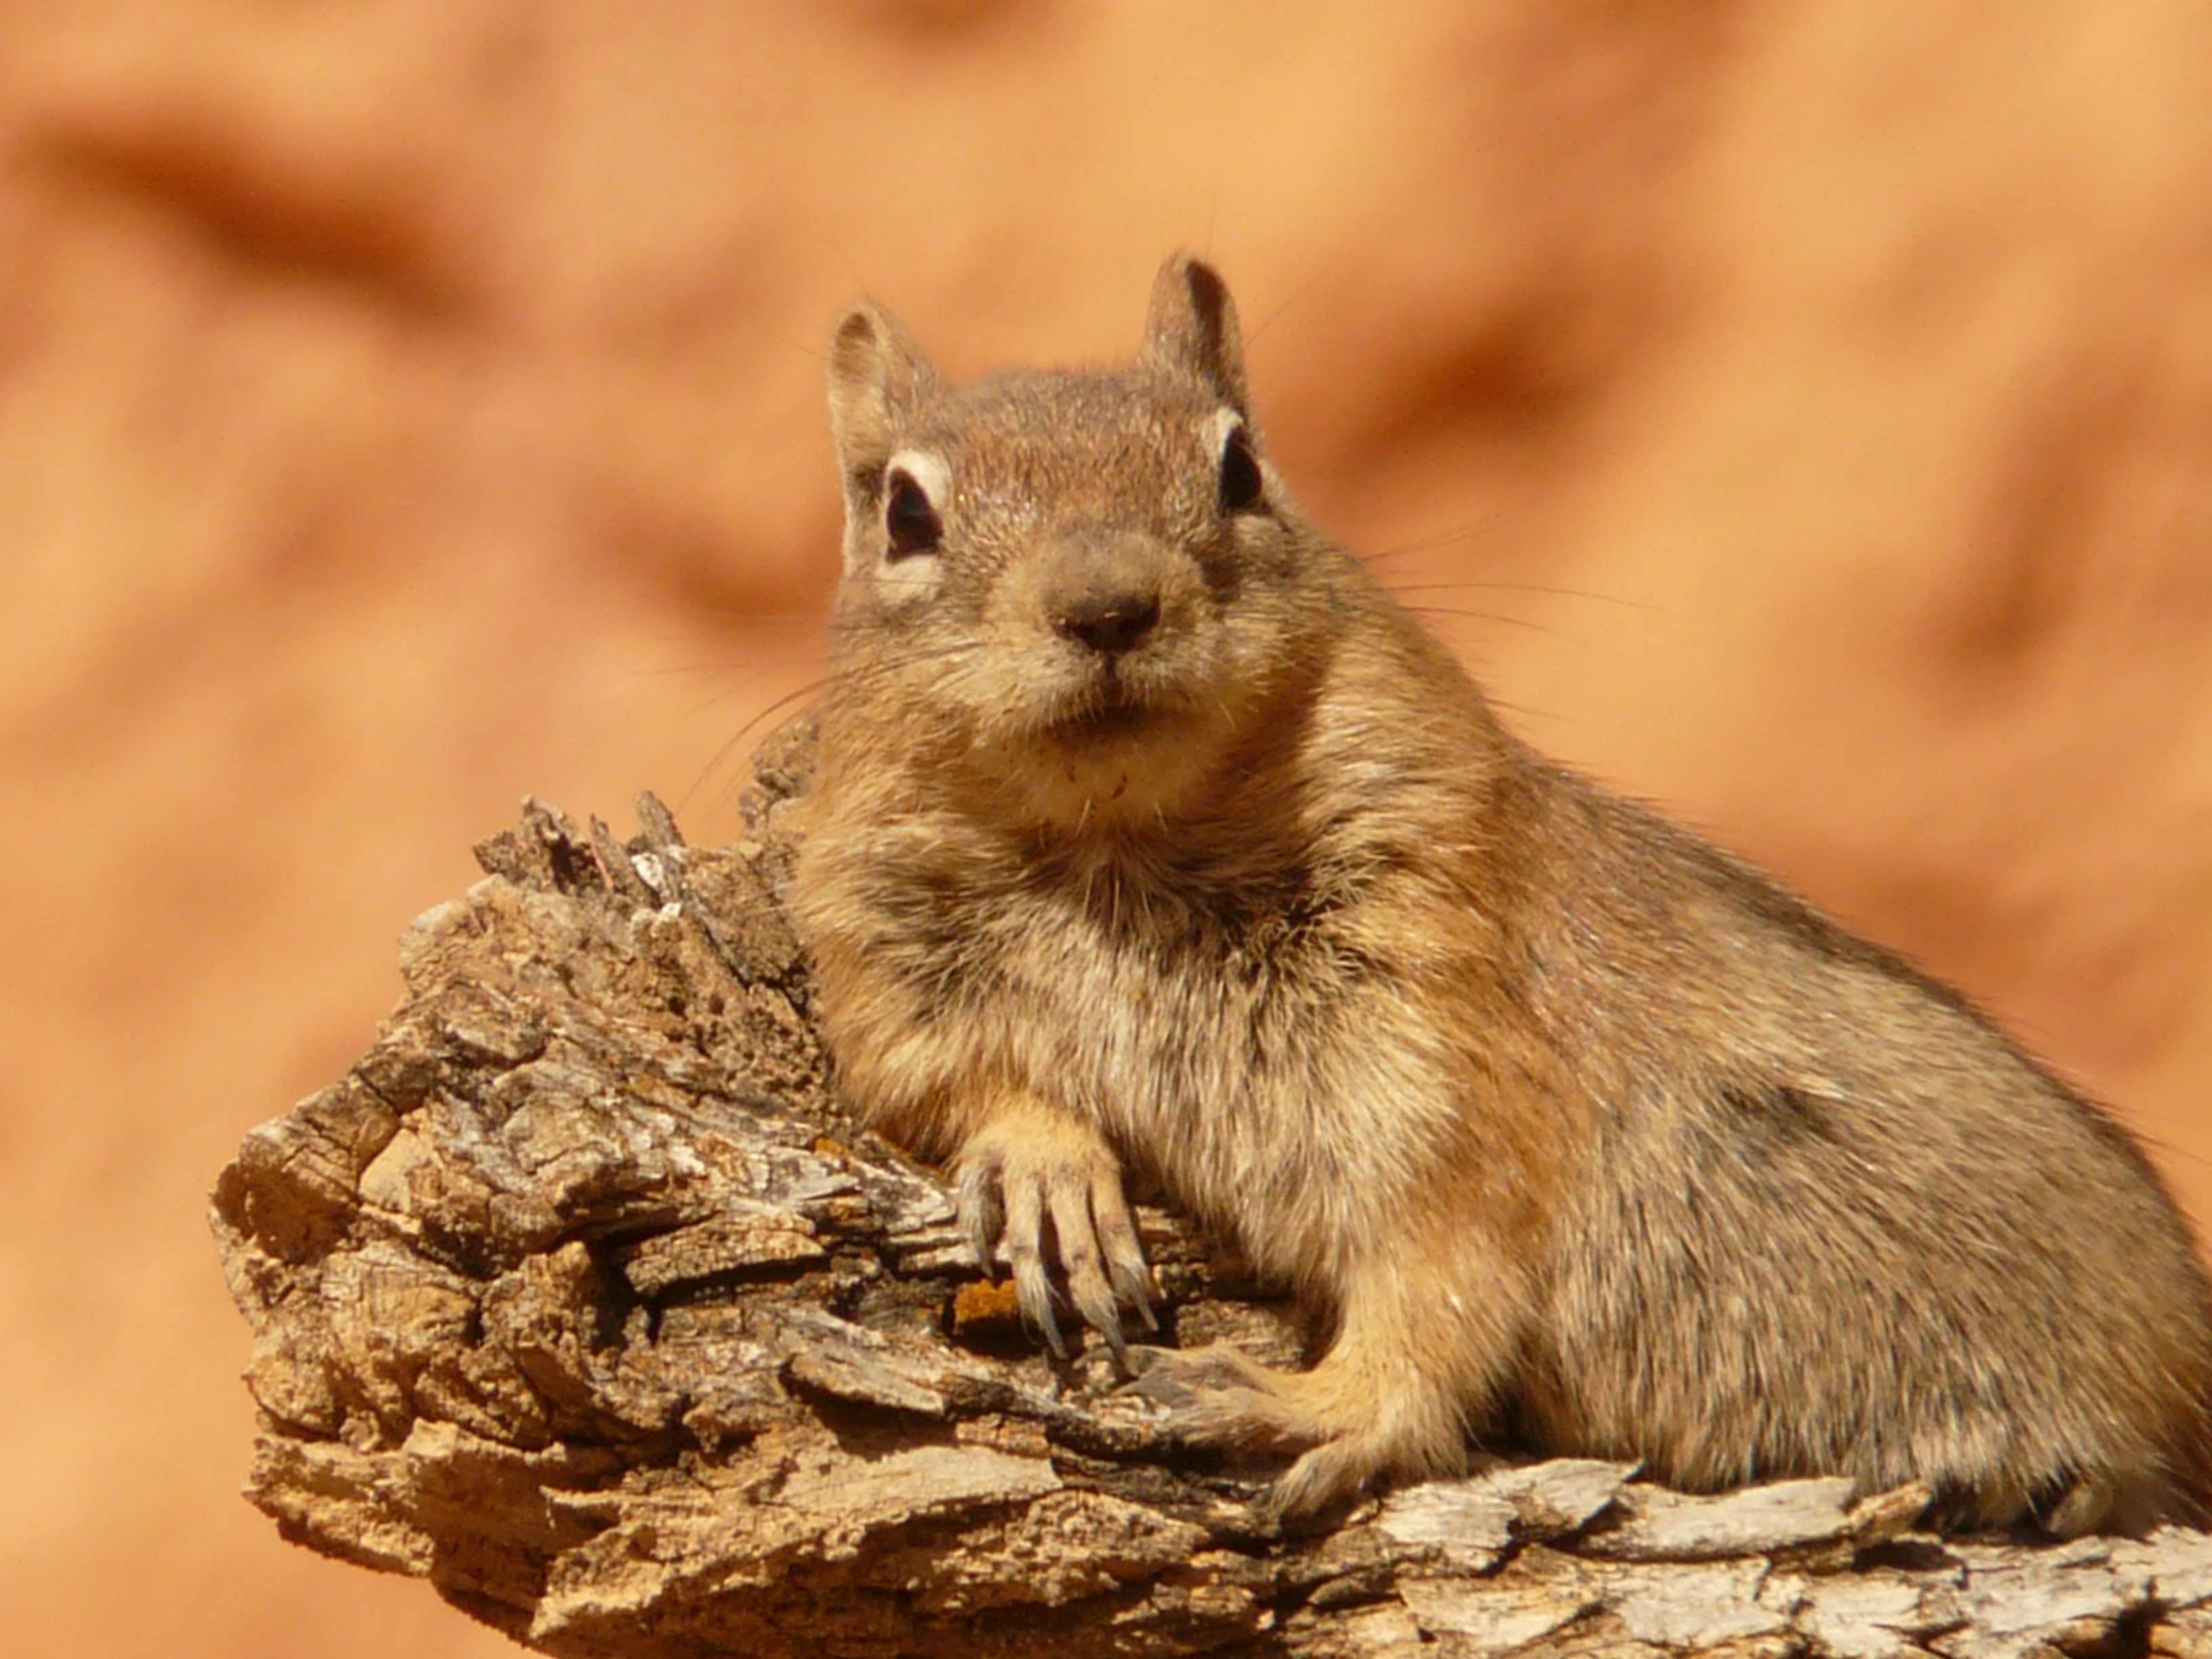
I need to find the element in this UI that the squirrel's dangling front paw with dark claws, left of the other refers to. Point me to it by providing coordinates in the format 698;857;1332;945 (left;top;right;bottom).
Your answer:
954;1111;1159;1367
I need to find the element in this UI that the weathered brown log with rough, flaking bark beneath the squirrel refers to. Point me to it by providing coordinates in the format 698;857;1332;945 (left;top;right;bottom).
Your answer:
215;723;2212;1659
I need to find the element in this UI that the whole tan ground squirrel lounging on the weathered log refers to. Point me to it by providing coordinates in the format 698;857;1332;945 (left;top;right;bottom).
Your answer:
792;257;2212;1533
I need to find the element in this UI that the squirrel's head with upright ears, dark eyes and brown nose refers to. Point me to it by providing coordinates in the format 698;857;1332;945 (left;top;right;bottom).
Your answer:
830;254;1314;825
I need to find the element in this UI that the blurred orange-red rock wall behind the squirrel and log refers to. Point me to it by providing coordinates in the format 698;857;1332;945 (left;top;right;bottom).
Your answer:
0;0;2212;1659
